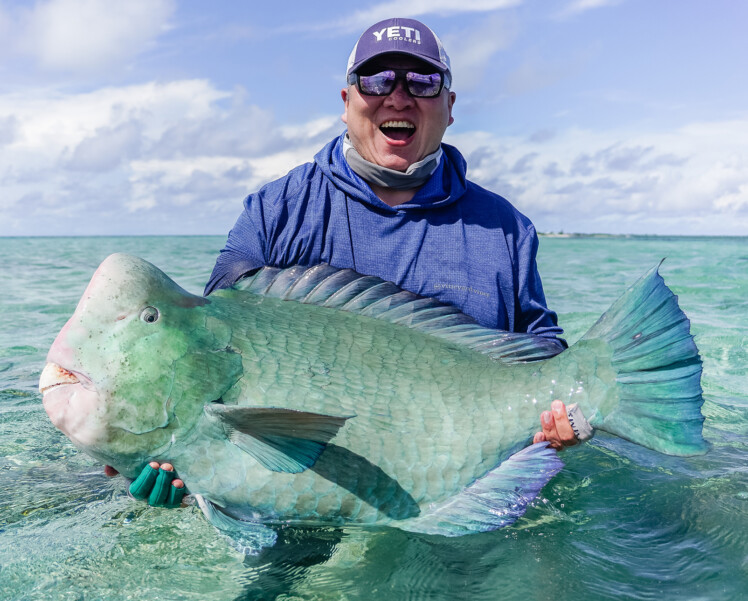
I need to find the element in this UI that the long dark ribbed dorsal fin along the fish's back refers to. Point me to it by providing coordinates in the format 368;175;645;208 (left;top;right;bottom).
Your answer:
234;263;561;363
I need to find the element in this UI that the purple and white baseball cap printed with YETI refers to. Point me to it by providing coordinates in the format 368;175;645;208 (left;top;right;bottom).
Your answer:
345;18;452;78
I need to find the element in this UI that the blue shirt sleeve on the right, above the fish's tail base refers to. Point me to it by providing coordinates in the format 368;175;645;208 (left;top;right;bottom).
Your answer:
515;225;568;350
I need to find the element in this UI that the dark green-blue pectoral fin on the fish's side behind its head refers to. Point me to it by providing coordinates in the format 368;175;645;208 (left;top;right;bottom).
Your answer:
206;405;349;474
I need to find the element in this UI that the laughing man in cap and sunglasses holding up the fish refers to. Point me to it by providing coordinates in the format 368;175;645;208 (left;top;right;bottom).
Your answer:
120;19;576;502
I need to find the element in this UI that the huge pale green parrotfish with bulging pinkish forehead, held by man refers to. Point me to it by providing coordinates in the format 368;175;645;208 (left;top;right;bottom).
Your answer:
40;254;706;536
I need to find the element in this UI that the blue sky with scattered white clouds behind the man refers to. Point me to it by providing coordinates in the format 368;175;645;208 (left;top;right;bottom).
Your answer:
0;0;748;236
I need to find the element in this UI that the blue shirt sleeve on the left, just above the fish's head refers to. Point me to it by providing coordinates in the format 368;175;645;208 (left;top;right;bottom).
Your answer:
203;189;270;296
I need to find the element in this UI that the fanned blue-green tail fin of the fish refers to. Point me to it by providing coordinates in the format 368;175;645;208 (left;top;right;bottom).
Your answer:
575;263;708;456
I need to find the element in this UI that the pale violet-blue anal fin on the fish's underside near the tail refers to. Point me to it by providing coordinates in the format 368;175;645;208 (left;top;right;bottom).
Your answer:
397;442;563;536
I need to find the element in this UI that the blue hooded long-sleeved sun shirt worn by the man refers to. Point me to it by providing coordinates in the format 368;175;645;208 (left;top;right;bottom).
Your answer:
205;133;566;348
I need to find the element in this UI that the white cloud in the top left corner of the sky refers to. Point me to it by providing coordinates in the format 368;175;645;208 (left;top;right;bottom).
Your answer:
9;0;176;72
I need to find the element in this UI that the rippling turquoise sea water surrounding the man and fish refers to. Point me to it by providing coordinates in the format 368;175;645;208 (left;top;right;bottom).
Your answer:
0;237;748;601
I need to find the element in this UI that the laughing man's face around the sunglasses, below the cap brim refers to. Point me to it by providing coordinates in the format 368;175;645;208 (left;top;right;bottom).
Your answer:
341;55;455;171
